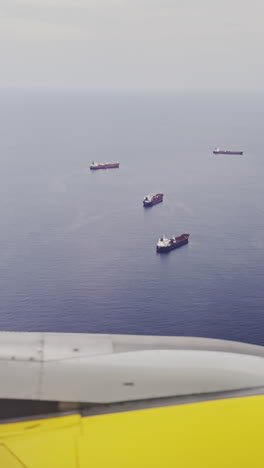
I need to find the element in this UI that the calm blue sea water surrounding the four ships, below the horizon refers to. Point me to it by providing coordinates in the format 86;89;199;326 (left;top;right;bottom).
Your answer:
0;92;264;344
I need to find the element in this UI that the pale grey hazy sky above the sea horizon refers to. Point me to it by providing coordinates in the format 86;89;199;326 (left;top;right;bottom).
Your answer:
0;0;264;92
